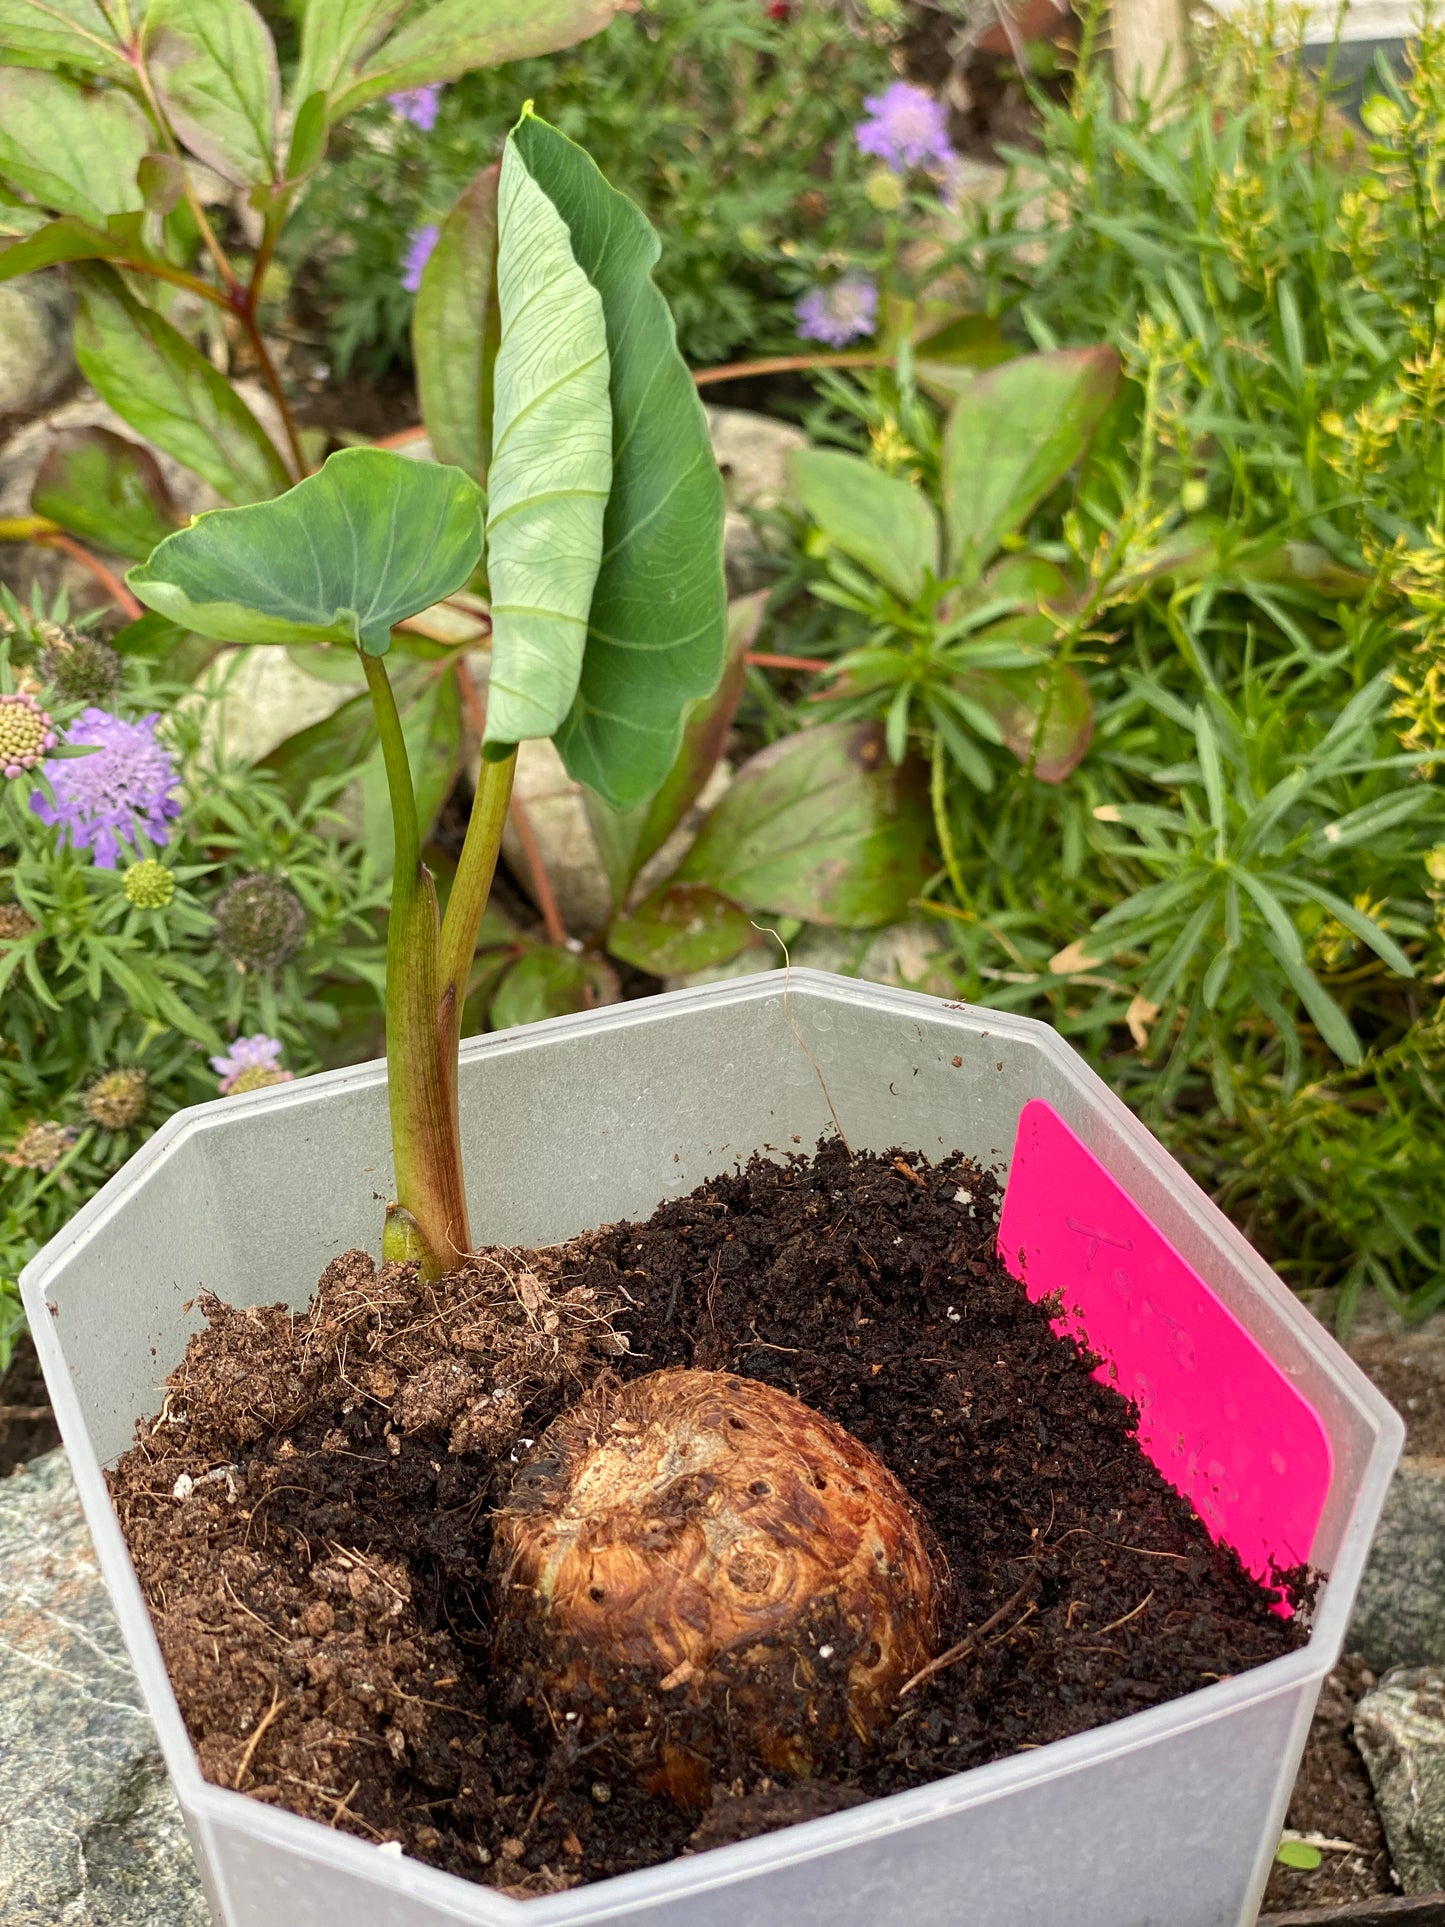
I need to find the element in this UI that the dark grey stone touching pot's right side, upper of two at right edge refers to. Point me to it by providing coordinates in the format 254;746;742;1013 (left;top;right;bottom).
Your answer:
1347;1459;1445;1672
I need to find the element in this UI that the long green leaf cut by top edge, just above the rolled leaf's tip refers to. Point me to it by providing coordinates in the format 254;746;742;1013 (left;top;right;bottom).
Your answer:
335;0;618;114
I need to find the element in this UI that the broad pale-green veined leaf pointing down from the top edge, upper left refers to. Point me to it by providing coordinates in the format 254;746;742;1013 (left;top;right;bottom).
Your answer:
145;0;281;187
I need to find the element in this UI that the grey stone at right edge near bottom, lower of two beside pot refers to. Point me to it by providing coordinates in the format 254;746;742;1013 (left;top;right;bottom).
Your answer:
1354;1667;1445;1894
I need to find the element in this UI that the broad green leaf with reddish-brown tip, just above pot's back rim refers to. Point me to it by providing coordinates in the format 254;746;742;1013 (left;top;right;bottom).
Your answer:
672;723;929;929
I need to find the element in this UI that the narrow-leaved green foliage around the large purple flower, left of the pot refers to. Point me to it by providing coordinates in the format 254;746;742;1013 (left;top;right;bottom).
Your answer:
0;601;383;1366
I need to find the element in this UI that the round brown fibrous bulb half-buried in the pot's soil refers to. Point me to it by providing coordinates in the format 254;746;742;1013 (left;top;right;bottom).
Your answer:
491;1370;934;1808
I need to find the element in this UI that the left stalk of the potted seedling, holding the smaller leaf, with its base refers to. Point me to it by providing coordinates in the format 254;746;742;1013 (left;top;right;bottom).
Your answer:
362;653;470;1278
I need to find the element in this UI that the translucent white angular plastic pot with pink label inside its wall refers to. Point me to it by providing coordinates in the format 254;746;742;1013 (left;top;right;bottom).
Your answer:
23;971;1403;1927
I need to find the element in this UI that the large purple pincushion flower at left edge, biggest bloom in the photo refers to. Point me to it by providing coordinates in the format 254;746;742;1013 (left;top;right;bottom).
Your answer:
31;709;181;869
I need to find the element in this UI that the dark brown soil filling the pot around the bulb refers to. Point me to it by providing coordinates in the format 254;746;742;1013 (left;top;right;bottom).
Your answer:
112;1143;1302;1894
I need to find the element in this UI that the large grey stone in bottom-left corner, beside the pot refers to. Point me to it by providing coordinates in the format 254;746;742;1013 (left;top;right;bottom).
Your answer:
0;1451;210;1927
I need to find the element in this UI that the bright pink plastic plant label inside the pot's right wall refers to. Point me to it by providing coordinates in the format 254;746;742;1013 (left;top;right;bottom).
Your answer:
998;1098;1331;1582
